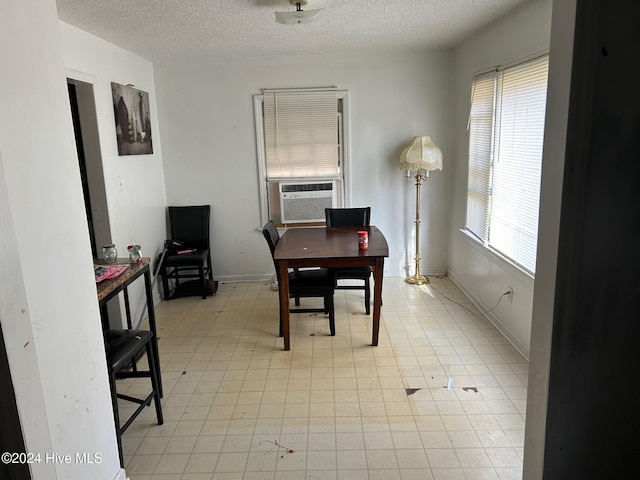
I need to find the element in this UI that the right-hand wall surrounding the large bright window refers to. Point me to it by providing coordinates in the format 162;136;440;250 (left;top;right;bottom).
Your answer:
449;0;552;357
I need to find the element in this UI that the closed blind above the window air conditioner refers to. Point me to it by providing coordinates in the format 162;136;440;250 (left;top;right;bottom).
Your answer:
264;90;340;180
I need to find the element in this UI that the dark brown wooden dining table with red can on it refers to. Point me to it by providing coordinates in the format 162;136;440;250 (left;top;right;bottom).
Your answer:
274;226;389;350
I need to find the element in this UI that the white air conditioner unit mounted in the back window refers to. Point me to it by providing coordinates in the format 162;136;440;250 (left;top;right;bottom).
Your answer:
279;181;336;223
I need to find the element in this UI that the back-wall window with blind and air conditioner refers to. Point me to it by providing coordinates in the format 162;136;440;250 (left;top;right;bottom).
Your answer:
254;88;348;224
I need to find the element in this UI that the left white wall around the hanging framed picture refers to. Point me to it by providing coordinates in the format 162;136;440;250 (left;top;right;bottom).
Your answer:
60;22;167;321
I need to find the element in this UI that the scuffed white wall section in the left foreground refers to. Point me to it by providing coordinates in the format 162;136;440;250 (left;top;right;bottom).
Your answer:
0;0;123;480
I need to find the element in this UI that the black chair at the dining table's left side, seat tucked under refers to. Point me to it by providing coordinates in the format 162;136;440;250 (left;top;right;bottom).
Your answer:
262;221;336;336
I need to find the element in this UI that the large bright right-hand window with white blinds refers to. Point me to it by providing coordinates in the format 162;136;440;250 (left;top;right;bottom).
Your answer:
466;55;548;274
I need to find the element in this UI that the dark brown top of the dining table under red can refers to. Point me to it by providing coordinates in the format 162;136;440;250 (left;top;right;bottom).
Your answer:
274;225;389;261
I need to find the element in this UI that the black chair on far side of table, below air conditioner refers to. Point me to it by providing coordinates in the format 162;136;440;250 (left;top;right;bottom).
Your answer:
324;207;371;315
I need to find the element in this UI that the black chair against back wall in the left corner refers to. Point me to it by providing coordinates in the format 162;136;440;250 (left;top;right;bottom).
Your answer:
159;205;213;300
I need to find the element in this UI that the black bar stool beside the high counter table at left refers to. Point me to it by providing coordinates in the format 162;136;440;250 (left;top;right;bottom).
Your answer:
103;329;164;466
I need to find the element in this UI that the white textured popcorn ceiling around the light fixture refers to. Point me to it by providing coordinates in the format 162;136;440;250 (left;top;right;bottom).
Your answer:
57;0;530;62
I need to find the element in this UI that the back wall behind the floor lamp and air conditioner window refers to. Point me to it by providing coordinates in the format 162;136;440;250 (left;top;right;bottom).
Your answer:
155;52;452;281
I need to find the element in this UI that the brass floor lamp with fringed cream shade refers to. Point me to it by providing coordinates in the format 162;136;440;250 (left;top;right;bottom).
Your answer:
400;137;442;285
